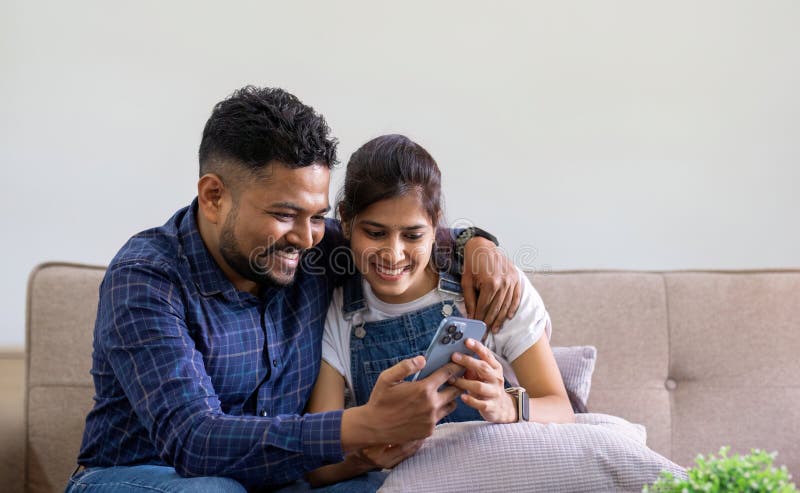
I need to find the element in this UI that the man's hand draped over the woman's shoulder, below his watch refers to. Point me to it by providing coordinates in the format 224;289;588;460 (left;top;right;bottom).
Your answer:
461;237;522;332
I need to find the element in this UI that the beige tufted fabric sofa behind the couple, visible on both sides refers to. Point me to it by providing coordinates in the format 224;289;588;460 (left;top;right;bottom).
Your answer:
6;263;800;492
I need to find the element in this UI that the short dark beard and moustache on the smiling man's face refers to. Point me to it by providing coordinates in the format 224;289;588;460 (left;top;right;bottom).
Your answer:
219;207;297;288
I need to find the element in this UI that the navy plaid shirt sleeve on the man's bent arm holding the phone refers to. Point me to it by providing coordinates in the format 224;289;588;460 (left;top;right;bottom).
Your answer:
95;261;343;485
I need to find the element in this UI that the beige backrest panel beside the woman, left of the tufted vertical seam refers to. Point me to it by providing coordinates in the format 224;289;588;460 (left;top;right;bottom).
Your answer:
529;272;672;457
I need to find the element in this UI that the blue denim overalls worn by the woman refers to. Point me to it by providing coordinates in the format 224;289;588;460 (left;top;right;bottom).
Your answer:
342;272;483;423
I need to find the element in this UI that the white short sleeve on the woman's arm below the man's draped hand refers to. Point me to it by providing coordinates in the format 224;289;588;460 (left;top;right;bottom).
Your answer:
494;268;551;362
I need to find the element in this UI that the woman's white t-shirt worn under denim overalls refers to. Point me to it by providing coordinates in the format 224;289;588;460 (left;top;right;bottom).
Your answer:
322;269;551;389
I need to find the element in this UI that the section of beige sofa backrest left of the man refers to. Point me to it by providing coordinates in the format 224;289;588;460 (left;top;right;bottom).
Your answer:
25;263;105;493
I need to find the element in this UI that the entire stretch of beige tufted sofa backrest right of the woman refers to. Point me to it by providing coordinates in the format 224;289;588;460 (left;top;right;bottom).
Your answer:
531;270;800;472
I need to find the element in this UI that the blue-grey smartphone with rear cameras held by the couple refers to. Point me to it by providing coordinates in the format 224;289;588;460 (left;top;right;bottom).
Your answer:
412;317;486;381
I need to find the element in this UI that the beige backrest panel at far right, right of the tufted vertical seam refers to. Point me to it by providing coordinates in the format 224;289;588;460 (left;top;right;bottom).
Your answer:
664;272;800;476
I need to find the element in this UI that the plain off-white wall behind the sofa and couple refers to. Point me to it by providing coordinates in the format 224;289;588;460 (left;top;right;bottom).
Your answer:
0;0;800;346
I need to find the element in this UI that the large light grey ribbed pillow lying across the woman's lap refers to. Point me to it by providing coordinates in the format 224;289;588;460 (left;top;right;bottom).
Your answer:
381;414;685;493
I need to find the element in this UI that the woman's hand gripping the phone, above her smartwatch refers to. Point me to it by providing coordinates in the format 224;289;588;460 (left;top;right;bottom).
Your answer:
450;339;517;423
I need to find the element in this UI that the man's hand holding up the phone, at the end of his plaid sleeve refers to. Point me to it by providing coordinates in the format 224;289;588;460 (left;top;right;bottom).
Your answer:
341;356;461;452
